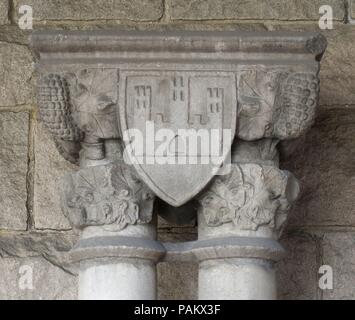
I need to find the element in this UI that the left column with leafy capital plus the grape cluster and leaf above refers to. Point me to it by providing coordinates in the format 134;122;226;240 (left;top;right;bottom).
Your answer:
34;69;165;300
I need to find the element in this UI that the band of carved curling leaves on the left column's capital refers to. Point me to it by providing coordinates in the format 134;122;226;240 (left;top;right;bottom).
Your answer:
61;163;154;230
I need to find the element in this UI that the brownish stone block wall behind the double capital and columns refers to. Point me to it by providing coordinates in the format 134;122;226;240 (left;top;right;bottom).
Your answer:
0;0;355;299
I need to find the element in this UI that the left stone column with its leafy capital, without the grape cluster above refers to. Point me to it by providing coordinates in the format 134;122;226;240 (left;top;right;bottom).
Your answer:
61;141;164;300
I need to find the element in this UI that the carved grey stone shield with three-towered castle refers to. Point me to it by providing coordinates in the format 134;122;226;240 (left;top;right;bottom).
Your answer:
118;70;237;206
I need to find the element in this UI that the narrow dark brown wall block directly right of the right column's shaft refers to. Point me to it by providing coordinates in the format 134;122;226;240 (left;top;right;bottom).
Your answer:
277;233;319;300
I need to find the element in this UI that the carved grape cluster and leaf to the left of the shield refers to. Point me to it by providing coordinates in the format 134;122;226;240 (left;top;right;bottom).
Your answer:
38;69;118;163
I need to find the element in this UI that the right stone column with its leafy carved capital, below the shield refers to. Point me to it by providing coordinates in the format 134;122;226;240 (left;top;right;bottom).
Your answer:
198;139;299;300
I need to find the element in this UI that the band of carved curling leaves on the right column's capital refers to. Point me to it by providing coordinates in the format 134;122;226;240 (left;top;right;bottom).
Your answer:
198;164;299;231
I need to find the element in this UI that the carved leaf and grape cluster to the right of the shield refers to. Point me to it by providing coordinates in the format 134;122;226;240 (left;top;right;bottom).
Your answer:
238;69;319;141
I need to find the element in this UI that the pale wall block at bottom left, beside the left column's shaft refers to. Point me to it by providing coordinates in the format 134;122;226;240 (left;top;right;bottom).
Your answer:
0;258;77;300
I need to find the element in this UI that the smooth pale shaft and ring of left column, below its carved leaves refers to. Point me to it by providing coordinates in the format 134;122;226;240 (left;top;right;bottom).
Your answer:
71;225;165;300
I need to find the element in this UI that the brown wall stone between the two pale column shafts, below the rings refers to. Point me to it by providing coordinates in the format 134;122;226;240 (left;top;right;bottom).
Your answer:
157;262;198;300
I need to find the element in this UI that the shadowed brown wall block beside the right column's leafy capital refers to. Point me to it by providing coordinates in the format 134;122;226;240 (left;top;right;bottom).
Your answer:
282;109;355;226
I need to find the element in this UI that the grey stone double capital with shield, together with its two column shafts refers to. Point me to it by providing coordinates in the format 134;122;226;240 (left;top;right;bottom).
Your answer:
32;31;326;298
